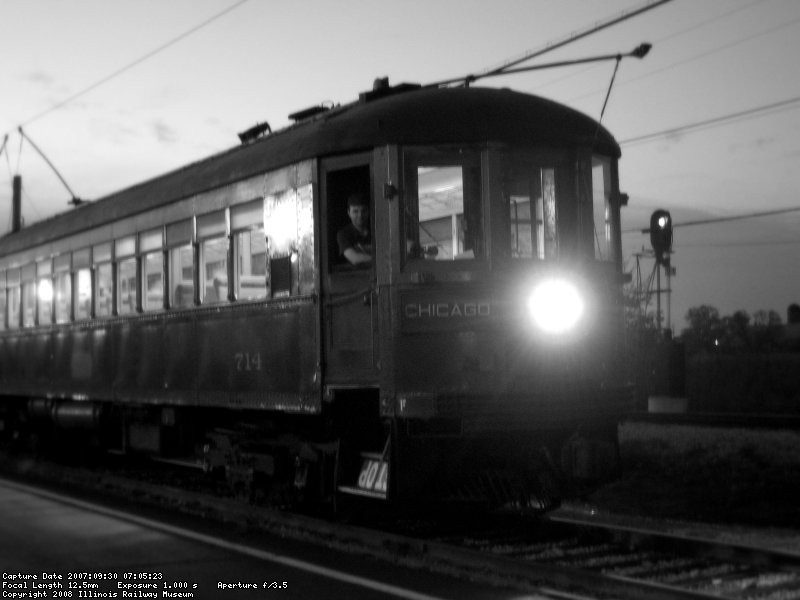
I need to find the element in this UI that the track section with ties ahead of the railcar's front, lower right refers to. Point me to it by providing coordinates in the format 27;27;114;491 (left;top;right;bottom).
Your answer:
428;510;800;600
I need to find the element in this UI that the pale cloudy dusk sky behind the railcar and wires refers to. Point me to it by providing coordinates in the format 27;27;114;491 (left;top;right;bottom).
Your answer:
0;0;800;333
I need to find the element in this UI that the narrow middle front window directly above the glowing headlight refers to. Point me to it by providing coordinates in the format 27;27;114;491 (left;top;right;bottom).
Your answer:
504;165;558;260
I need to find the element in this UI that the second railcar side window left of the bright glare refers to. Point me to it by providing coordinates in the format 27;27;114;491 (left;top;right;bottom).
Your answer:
197;210;228;304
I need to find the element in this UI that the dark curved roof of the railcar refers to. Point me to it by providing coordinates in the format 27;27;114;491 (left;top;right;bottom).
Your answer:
0;84;620;254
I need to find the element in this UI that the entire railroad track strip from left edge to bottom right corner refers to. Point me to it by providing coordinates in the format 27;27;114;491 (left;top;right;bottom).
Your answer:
2;454;800;600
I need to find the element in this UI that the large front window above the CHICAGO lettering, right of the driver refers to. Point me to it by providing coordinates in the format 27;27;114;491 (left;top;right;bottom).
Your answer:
405;156;483;261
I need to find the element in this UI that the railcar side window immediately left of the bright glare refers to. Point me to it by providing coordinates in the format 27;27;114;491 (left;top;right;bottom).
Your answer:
231;199;267;300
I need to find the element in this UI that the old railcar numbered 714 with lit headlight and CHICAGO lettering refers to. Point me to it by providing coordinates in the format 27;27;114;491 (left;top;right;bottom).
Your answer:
0;81;632;508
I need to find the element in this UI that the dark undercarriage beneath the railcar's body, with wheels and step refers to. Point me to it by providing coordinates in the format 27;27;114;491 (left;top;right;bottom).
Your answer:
0;390;619;511
